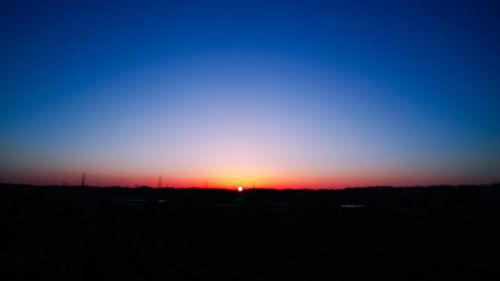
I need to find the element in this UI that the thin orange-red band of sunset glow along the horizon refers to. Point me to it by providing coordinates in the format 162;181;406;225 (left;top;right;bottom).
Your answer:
5;164;492;190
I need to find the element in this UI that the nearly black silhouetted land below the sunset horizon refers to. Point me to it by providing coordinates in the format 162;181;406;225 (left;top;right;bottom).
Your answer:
0;185;500;281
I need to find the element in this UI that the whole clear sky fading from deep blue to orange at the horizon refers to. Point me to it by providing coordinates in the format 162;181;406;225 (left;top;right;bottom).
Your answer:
0;0;500;188
